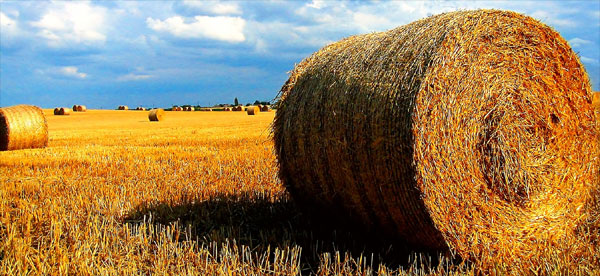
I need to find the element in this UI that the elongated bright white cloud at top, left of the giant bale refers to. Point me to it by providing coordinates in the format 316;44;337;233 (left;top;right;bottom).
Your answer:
146;16;246;42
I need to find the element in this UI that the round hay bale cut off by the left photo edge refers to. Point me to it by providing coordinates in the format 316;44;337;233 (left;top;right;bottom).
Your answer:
0;105;48;151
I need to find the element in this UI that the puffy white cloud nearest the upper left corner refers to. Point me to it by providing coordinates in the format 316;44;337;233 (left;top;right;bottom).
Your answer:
31;2;106;47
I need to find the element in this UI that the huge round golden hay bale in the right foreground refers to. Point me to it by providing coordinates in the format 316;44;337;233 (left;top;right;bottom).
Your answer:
274;10;600;264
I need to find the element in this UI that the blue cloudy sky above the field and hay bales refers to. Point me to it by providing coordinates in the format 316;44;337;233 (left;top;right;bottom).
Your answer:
0;0;600;109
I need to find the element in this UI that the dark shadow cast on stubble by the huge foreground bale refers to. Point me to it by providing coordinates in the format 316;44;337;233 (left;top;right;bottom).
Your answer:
123;196;450;274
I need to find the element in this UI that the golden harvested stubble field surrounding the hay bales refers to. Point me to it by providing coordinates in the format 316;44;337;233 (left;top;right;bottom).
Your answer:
0;110;598;275
